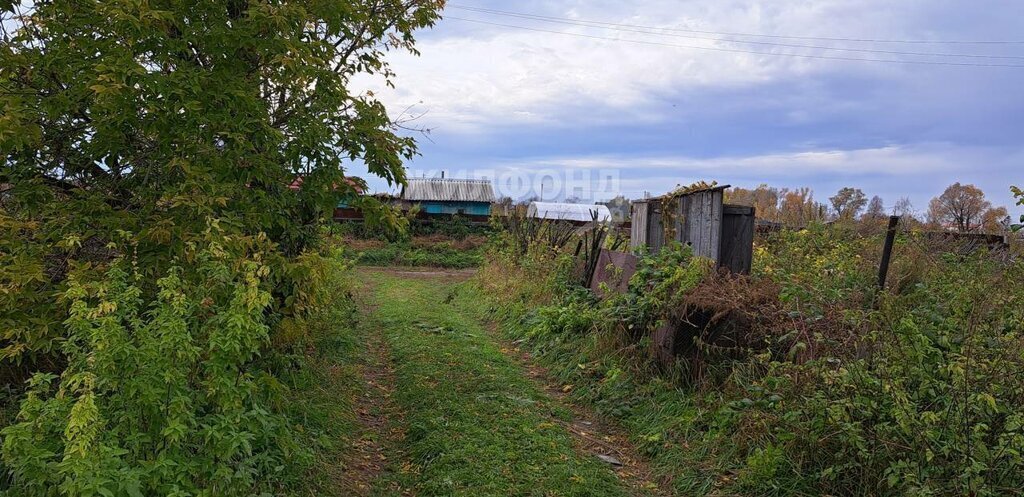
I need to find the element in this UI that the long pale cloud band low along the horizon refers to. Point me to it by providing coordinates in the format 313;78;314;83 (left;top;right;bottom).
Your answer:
376;143;1024;207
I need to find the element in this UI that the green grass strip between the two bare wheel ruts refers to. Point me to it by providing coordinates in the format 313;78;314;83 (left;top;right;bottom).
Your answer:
364;272;627;497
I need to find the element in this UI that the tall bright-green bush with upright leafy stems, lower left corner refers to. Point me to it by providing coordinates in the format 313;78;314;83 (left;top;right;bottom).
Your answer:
3;234;298;496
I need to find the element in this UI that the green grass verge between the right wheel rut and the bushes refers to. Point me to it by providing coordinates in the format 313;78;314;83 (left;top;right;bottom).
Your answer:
485;326;737;495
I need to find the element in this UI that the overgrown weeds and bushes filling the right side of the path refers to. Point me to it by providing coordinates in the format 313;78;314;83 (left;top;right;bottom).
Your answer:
479;219;1024;496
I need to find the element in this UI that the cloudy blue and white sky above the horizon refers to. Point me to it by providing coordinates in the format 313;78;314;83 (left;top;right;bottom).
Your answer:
353;0;1024;217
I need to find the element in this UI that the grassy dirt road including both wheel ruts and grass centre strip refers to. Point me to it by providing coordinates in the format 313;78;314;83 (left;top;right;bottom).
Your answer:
345;268;658;496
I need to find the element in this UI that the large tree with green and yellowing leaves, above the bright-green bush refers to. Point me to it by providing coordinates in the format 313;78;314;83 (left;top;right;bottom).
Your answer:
0;0;442;356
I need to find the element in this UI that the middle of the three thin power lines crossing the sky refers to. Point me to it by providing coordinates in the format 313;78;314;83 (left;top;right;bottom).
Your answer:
455;6;1024;60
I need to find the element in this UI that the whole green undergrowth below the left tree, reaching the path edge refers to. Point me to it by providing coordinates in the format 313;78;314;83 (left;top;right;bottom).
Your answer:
2;230;364;496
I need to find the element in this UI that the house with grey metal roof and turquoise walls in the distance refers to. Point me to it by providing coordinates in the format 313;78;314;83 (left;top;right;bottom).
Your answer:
399;177;495;216
